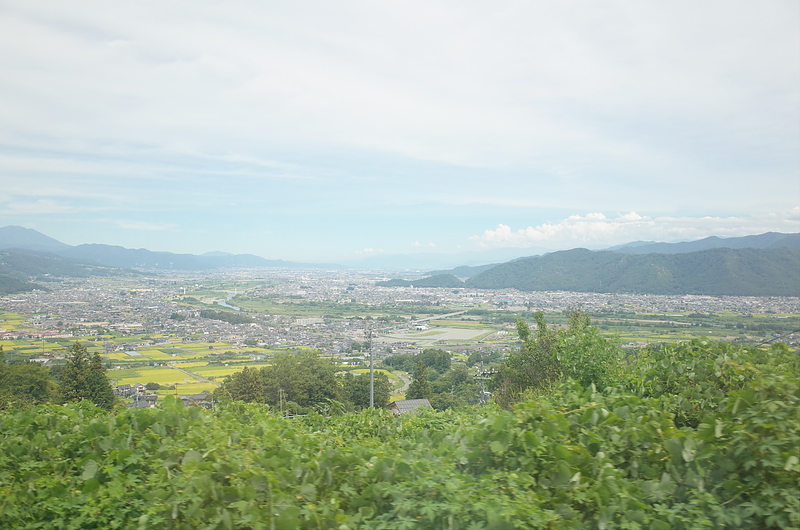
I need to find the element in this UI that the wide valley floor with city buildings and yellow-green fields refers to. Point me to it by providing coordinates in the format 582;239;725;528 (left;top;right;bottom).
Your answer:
0;269;800;402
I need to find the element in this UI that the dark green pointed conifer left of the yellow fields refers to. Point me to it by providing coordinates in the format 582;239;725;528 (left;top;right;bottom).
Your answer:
59;342;114;409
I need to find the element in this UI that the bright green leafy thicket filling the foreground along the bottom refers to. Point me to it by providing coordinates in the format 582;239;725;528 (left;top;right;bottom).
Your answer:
0;336;800;530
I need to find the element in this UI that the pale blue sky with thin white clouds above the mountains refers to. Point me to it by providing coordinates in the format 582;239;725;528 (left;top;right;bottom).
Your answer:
0;0;800;262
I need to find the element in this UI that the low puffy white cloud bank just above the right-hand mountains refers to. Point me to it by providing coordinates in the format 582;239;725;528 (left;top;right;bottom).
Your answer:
470;208;800;248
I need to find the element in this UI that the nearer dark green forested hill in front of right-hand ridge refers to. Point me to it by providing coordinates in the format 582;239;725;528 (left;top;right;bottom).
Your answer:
466;248;800;296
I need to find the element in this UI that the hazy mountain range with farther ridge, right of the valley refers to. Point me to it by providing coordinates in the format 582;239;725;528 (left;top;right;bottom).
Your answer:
383;232;800;296
